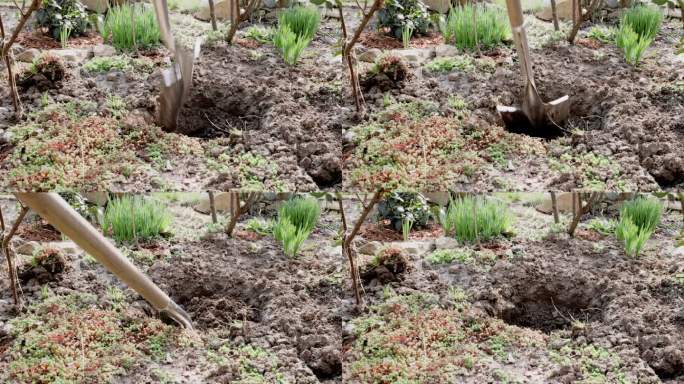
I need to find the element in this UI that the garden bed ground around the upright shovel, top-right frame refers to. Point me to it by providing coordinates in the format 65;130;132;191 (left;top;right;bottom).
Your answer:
344;15;684;191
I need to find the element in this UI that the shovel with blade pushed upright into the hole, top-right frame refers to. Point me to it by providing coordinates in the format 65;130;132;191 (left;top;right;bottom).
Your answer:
496;0;570;137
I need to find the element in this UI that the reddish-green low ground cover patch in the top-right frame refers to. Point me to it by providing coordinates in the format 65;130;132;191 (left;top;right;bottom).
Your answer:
345;98;535;191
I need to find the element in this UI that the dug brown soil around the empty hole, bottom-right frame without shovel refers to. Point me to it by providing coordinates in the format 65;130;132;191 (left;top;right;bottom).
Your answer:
479;240;684;380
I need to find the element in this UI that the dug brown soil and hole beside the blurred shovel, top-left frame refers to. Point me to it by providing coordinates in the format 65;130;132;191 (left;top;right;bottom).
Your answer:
179;38;351;190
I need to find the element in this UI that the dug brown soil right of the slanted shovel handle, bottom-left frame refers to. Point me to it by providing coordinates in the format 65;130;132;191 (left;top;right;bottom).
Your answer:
150;234;342;383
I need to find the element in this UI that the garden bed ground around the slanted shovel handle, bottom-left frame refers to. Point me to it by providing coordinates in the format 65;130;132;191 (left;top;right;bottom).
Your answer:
0;192;345;384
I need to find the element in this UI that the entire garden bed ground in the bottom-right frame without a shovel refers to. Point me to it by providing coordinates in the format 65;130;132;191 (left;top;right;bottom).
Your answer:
343;193;684;383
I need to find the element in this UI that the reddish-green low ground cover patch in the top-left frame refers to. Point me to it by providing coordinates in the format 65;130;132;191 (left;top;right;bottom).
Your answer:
8;103;199;191
